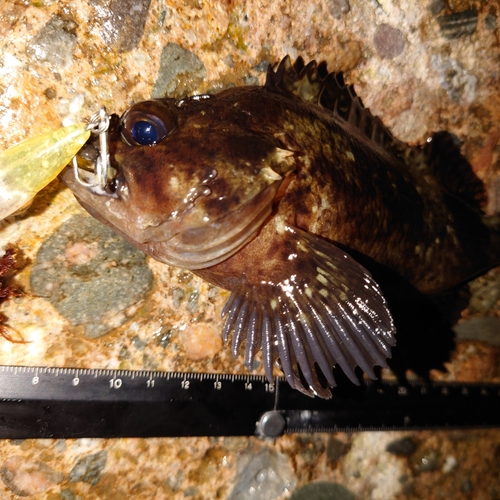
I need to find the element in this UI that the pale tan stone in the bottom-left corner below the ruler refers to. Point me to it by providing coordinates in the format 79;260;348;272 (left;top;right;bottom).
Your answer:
0;455;64;497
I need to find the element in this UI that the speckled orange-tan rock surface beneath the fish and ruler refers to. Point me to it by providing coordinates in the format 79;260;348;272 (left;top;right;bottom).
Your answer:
0;0;500;500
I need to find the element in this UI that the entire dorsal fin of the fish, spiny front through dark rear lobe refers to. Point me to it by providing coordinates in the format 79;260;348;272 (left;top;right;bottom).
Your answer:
265;56;486;212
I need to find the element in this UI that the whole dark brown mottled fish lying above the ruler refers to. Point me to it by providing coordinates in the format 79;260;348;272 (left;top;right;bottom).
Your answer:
61;56;500;398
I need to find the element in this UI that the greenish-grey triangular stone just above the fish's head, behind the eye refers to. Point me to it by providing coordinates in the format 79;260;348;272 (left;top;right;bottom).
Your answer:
152;43;207;98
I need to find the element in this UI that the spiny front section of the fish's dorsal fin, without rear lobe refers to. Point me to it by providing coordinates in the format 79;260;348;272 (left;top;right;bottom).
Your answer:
265;56;404;156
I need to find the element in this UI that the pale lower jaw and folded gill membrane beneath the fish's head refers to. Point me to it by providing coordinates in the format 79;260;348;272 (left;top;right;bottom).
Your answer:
59;167;282;270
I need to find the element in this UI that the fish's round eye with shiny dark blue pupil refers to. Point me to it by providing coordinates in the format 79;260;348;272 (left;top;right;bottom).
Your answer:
121;100;177;146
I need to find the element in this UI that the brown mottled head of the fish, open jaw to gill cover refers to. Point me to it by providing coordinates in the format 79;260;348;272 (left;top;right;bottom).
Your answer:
62;96;294;269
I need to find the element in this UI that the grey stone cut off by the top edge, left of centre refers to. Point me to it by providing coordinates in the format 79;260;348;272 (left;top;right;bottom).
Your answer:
93;0;151;52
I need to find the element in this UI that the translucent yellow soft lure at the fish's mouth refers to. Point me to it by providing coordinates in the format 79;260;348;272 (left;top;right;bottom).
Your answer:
0;123;90;220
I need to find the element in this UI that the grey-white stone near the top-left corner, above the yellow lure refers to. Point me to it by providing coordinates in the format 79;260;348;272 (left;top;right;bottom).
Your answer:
26;16;76;68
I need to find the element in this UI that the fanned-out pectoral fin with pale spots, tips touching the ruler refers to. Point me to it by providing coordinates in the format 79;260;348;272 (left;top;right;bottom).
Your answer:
223;226;395;398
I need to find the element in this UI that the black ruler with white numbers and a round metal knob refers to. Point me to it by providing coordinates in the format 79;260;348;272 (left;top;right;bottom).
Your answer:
0;366;500;439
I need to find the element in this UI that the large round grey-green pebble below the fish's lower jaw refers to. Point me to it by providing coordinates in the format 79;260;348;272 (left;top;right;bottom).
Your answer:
31;215;153;338
